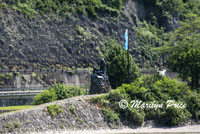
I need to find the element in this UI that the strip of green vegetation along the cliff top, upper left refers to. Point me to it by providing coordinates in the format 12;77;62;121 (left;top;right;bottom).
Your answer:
0;0;123;17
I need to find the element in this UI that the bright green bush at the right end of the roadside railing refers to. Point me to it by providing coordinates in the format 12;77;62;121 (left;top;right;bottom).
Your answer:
32;90;57;105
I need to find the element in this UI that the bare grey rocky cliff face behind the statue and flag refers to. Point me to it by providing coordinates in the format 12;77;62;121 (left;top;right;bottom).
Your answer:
0;0;146;68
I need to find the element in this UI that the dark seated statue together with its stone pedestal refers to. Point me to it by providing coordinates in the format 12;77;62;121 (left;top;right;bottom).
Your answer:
90;59;111;94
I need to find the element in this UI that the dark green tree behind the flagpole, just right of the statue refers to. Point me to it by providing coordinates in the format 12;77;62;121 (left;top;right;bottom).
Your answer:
105;40;138;88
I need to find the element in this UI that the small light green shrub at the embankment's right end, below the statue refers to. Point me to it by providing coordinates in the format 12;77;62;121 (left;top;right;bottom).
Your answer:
102;108;120;124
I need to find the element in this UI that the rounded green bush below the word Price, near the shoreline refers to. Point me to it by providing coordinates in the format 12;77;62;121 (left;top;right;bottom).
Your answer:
160;107;191;126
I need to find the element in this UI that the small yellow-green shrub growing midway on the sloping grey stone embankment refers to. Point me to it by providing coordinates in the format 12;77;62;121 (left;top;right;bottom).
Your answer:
47;104;63;117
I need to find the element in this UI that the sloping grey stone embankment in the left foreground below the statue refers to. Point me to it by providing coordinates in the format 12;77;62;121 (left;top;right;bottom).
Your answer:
0;95;120;134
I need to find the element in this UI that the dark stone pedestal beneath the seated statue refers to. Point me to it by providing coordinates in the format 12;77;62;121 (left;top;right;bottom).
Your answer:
90;73;111;94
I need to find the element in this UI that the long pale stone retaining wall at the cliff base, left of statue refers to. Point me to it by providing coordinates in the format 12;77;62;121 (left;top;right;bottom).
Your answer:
0;69;91;91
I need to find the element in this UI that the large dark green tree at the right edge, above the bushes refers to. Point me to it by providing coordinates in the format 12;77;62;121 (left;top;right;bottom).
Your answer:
168;15;200;88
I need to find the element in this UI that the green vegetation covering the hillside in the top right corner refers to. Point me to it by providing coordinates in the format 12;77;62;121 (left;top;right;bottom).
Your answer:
137;0;200;26
